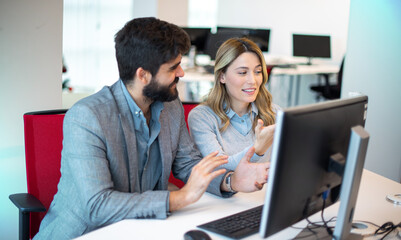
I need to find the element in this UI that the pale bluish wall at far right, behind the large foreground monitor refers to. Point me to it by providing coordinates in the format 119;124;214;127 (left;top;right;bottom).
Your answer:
342;0;401;182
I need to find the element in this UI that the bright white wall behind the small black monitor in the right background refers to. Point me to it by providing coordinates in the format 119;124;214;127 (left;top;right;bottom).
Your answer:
217;0;350;65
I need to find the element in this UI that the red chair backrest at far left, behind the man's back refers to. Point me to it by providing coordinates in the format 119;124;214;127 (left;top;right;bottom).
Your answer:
24;109;67;238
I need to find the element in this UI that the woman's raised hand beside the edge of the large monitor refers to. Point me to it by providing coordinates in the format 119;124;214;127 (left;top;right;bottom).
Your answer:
254;119;276;156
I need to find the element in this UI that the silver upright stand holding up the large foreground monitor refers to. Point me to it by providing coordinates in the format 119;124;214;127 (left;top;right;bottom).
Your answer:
296;126;369;240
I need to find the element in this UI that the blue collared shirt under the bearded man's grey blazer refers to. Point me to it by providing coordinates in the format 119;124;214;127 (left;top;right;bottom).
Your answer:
120;80;163;192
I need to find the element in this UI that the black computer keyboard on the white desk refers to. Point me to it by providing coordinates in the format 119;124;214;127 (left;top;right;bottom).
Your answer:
198;205;263;239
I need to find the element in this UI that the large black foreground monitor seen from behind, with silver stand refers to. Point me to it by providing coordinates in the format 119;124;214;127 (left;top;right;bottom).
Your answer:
260;96;368;239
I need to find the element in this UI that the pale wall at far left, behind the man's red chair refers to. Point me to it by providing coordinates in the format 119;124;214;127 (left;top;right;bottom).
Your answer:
0;0;63;240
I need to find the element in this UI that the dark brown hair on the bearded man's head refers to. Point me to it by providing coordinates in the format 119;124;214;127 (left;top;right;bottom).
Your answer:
114;17;191;84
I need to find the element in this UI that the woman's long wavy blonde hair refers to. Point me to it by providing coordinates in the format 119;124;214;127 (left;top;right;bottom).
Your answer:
203;38;275;131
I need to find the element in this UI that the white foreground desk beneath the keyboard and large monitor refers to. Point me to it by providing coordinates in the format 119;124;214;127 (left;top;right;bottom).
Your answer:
77;170;401;240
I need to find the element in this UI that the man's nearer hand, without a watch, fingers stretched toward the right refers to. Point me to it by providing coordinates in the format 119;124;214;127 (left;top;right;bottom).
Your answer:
169;151;228;212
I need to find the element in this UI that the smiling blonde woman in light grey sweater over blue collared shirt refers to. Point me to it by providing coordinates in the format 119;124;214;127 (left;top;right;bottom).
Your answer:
188;38;278;170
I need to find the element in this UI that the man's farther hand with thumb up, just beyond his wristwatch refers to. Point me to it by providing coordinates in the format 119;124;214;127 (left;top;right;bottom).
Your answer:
231;147;270;192
